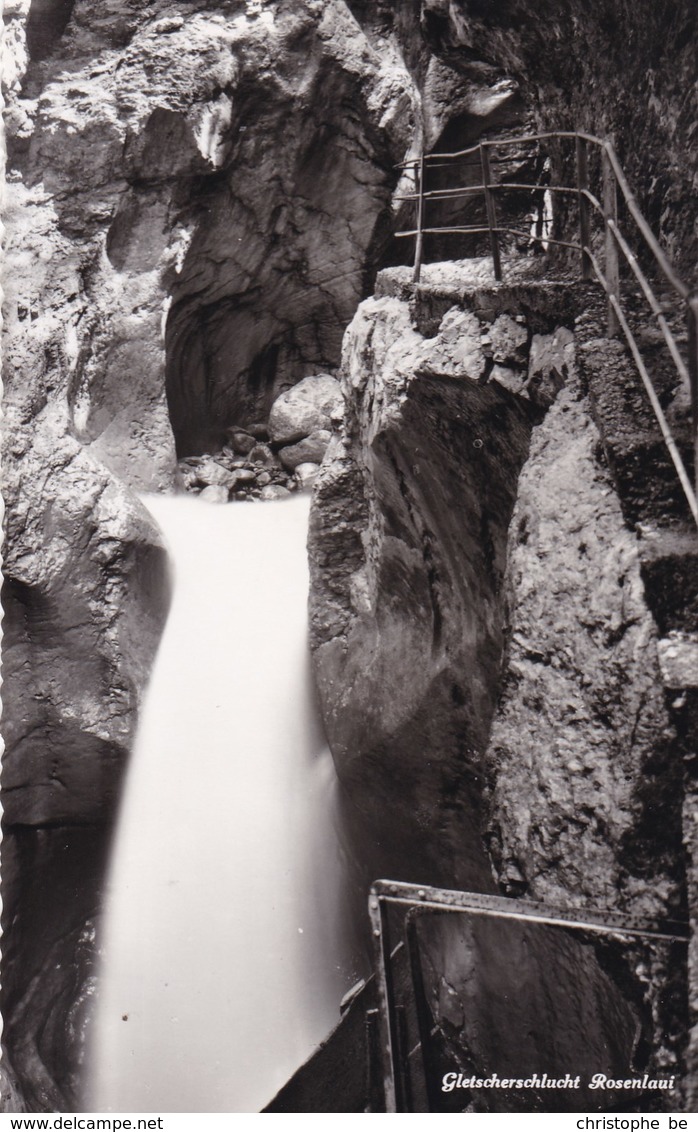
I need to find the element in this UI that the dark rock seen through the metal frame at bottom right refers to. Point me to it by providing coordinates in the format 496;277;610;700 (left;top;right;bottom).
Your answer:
419;916;653;1113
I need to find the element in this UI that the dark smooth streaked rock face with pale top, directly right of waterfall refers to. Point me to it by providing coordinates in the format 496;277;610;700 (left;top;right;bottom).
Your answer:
309;269;567;889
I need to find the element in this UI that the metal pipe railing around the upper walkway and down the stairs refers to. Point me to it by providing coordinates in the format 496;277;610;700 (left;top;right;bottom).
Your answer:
396;130;698;525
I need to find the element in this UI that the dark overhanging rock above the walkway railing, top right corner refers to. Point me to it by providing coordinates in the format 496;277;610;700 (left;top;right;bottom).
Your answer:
421;0;698;275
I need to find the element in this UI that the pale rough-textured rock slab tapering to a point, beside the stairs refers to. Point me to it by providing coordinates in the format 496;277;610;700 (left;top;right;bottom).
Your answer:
488;384;681;915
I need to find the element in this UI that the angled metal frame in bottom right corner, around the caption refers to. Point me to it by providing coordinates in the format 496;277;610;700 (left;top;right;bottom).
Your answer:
369;881;689;1113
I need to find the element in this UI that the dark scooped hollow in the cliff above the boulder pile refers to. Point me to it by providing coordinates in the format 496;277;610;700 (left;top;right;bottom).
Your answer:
166;66;396;456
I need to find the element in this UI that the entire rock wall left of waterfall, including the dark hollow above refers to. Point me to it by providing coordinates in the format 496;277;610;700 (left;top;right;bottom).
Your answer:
2;0;527;1108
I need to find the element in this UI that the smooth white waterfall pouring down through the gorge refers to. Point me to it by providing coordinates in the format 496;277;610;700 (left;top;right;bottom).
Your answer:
86;496;356;1112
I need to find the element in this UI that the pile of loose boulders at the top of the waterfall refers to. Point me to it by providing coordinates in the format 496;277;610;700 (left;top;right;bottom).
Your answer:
178;374;344;503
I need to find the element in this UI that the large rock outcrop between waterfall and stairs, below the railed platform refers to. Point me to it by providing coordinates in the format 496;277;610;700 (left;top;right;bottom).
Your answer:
310;263;687;1095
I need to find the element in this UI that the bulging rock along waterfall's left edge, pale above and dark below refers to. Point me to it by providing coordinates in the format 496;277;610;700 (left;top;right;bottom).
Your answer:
2;425;167;1112
